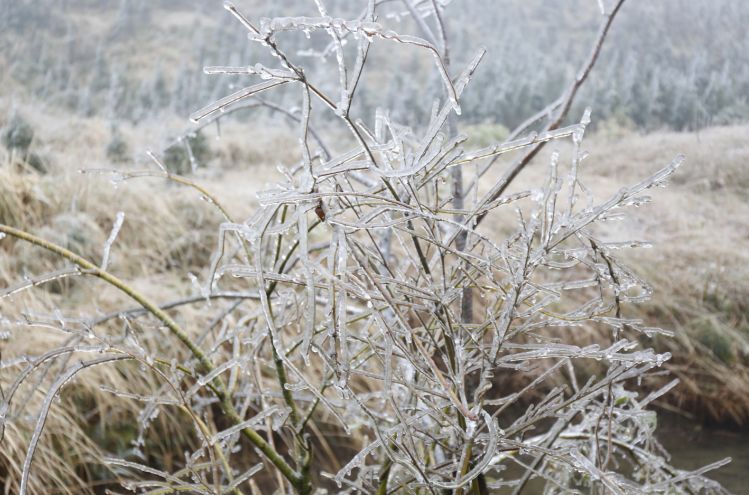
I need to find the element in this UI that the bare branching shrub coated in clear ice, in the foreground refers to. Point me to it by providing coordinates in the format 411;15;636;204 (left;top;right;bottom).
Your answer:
0;0;728;495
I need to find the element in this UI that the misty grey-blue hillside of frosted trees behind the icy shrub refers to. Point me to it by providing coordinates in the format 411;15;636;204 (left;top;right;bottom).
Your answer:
0;0;749;136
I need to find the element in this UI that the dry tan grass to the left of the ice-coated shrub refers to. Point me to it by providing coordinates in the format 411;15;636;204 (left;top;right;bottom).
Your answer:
0;101;294;494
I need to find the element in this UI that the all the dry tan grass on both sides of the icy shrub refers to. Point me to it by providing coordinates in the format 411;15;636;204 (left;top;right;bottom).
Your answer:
0;102;749;493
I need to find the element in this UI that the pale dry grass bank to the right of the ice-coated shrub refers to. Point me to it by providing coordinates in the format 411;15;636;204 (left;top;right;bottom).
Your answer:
476;126;749;425
